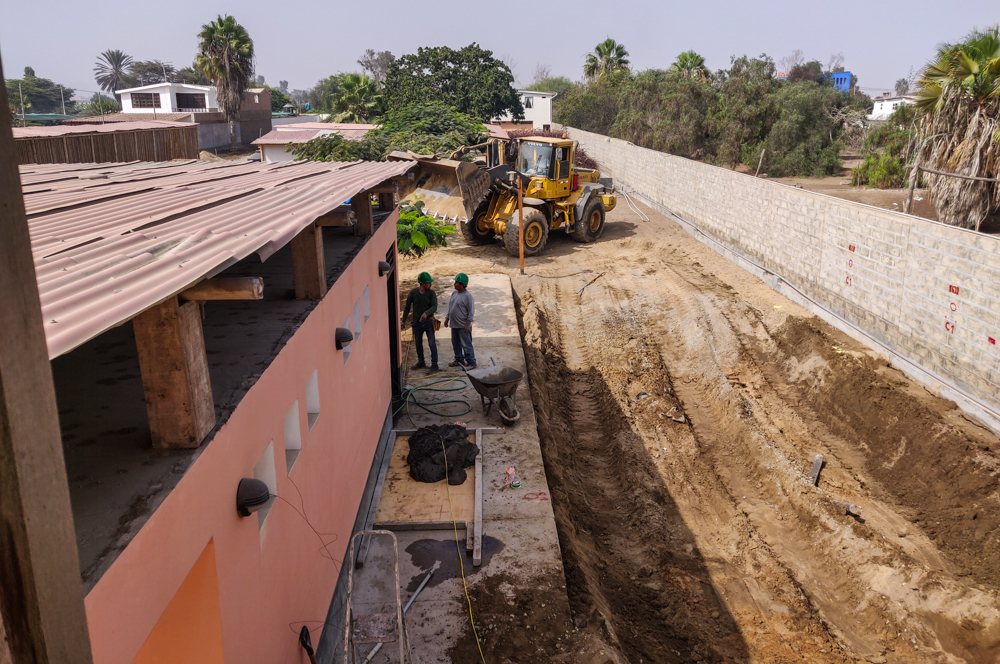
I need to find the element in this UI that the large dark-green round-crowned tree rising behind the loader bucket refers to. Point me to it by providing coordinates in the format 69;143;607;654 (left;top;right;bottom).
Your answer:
385;43;524;120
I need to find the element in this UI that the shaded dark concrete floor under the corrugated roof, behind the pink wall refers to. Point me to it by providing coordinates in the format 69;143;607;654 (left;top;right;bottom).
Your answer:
52;220;388;591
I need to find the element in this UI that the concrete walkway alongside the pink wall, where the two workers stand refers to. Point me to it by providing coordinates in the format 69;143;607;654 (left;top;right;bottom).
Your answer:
348;274;569;664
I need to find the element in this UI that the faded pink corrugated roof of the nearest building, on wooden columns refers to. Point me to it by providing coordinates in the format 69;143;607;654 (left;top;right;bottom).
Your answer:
21;161;413;358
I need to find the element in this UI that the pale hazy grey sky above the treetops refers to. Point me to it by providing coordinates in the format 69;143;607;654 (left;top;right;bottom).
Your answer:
0;0;1000;100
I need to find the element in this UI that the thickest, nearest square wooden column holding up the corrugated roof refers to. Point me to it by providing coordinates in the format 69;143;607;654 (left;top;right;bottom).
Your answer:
132;295;215;449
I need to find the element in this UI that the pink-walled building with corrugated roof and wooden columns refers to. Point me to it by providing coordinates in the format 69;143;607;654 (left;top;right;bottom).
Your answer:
21;157;411;664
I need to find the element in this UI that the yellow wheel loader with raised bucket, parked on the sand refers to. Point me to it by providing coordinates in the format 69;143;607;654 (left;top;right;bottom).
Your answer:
389;136;618;256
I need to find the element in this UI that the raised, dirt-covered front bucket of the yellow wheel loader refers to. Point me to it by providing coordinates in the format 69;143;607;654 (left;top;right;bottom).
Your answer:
388;152;490;222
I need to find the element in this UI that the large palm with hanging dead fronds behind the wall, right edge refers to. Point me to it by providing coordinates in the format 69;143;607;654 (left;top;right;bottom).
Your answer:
916;26;1000;230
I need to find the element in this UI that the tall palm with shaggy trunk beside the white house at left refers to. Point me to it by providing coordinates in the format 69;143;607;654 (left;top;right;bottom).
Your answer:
195;15;254;150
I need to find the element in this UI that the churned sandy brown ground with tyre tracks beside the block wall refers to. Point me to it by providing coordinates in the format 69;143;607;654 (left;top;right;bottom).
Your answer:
401;204;1000;664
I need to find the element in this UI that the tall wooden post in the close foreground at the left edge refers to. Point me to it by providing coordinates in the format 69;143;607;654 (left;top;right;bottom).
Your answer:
0;54;92;664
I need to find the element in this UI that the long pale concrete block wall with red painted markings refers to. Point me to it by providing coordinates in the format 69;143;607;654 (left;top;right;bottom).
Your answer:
568;128;1000;428
